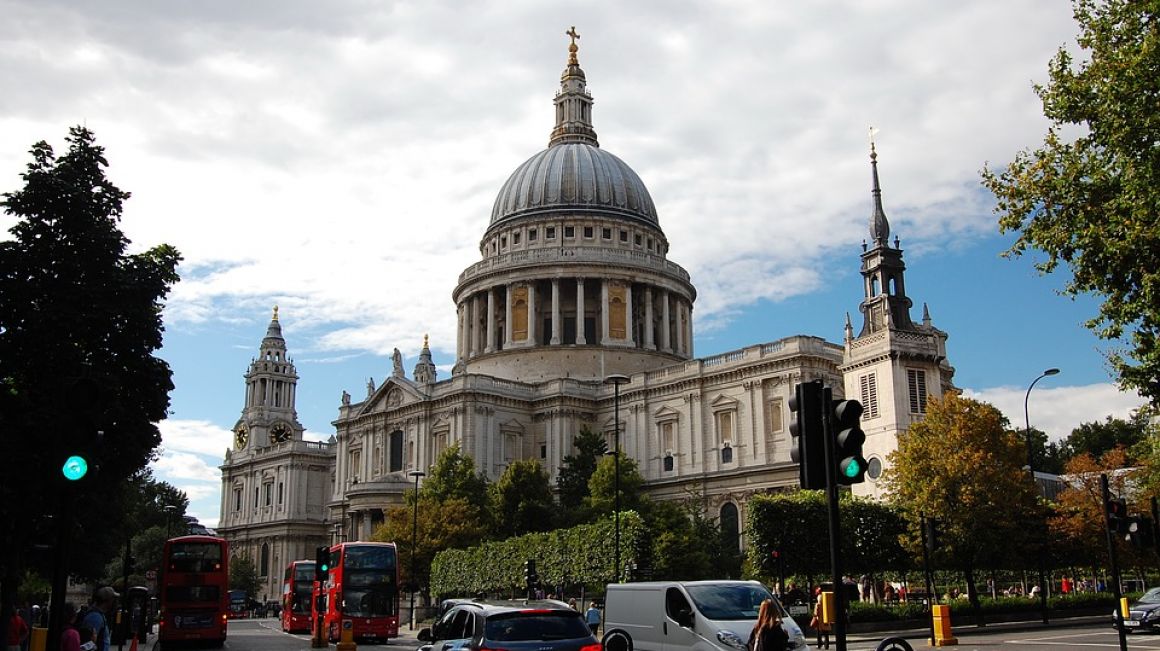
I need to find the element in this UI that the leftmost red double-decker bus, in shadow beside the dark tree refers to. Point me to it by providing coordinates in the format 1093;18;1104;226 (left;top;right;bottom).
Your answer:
157;536;230;649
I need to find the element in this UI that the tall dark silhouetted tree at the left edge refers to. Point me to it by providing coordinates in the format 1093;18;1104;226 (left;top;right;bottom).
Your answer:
0;126;180;621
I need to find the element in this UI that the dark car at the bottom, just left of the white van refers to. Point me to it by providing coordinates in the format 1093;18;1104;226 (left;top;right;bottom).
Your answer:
419;600;601;651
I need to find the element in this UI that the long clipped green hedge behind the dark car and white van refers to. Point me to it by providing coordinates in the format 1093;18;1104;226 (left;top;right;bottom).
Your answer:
430;512;647;596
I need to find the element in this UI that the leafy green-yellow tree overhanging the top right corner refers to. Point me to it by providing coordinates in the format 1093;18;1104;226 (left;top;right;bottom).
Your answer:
983;0;1160;405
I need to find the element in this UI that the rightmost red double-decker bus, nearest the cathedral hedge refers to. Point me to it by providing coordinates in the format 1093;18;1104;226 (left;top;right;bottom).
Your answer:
321;542;399;642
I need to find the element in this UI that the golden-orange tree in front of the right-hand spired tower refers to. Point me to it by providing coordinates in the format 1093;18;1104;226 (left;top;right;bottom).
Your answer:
883;393;1045;608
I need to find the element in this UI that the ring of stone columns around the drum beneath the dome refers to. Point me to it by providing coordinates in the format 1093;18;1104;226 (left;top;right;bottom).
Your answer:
456;277;693;361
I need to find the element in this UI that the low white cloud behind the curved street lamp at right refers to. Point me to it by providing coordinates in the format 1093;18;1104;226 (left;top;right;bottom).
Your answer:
964;383;1146;441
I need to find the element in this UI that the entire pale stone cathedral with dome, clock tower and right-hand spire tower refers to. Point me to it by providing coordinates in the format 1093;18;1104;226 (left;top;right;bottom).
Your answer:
218;38;954;599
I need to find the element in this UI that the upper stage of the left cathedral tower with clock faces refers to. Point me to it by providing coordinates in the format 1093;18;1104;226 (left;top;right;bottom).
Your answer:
233;306;304;454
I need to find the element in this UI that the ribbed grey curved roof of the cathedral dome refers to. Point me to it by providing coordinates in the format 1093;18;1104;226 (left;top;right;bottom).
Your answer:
491;142;658;226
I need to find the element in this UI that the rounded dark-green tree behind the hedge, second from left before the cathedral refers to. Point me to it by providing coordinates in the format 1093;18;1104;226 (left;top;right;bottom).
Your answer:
492;458;556;537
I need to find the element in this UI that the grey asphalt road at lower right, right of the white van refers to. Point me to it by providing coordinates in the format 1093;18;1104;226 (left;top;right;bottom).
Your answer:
844;622;1160;651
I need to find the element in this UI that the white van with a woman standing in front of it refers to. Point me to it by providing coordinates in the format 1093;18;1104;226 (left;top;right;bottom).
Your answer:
603;581;810;651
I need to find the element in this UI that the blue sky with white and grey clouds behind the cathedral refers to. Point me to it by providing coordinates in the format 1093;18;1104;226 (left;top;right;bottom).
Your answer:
0;0;1144;526
